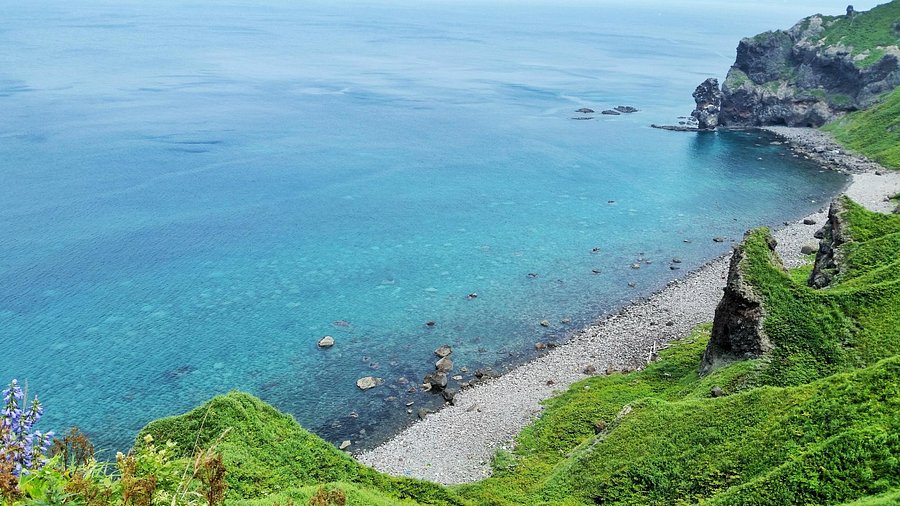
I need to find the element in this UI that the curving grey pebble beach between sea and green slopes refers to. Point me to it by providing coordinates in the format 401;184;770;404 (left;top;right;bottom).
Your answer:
356;127;900;484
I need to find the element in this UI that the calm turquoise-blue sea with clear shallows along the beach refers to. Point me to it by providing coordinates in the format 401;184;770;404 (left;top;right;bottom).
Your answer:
0;2;845;449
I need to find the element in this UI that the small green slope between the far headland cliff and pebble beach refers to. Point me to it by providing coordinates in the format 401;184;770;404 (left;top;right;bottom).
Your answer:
823;86;900;169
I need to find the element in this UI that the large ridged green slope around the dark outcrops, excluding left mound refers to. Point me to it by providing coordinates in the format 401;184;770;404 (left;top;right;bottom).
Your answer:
463;201;900;504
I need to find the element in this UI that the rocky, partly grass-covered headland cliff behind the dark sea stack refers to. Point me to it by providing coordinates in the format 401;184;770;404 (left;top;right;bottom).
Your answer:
718;0;900;126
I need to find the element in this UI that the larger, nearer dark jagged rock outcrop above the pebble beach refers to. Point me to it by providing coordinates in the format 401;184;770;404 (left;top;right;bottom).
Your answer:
700;231;777;374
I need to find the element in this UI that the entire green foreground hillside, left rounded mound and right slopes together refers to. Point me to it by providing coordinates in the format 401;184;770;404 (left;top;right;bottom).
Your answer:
89;196;900;505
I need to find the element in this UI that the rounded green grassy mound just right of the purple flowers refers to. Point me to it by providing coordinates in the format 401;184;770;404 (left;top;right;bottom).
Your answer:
137;392;465;504
